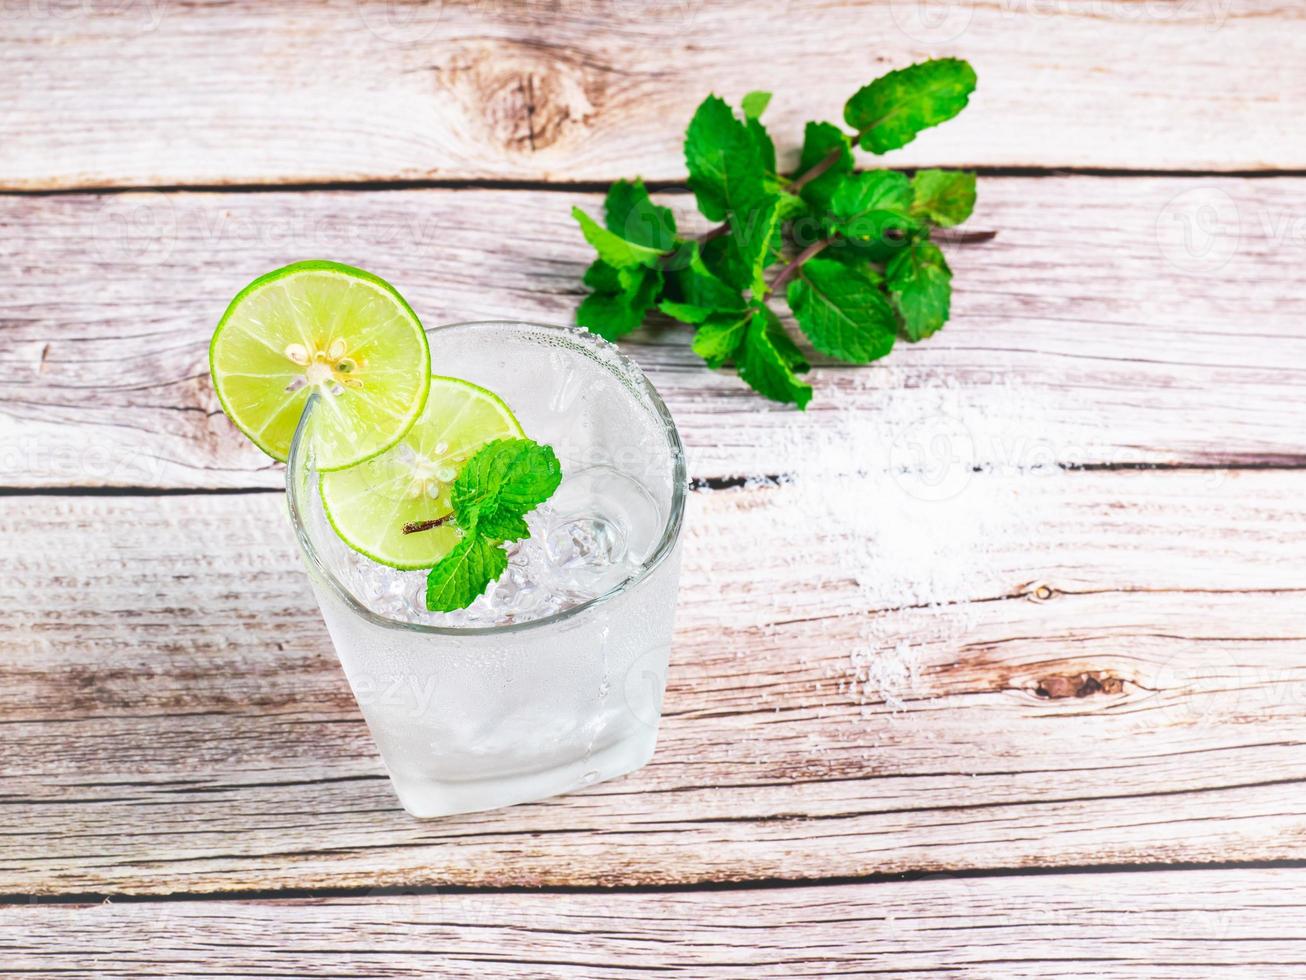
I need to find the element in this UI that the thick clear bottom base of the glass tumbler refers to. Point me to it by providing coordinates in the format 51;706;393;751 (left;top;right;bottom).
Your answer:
390;727;657;819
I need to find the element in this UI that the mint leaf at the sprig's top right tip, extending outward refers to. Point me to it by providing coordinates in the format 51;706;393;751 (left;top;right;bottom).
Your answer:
844;57;976;153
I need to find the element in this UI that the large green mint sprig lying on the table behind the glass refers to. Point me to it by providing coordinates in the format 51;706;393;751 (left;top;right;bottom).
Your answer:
572;57;991;408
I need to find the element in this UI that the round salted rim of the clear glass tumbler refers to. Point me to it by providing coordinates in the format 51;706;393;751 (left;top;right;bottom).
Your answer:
286;320;688;636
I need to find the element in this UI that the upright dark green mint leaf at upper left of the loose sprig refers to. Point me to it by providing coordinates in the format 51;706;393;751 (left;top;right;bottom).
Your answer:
684;95;767;221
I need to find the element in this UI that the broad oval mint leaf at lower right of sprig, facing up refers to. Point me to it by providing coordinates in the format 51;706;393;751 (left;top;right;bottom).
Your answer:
789;257;897;365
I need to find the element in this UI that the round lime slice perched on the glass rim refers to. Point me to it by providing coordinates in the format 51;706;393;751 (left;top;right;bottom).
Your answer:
209;261;431;470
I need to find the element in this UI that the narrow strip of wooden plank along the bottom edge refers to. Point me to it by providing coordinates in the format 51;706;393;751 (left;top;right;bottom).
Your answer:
0;869;1306;980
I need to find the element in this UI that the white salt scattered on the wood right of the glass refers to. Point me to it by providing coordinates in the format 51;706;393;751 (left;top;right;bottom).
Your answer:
746;366;1096;716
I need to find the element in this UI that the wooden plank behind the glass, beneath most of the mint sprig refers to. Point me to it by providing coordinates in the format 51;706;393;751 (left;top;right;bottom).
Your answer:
0;178;1306;487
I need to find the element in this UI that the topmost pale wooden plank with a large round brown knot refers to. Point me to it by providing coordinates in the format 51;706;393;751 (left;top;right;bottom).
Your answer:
0;0;1306;188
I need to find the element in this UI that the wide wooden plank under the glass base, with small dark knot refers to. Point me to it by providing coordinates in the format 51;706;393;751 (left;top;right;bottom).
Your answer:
0;472;1306;894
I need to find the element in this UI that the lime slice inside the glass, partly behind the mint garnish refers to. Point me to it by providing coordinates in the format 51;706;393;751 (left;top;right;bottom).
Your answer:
321;376;525;570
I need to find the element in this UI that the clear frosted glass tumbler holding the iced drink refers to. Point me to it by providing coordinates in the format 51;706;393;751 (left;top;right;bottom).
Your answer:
286;323;686;817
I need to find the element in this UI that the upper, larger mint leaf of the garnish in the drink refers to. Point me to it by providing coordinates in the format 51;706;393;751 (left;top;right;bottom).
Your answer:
449;439;562;541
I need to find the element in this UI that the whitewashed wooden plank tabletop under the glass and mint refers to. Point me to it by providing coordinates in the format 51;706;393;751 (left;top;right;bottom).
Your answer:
0;0;1306;977
